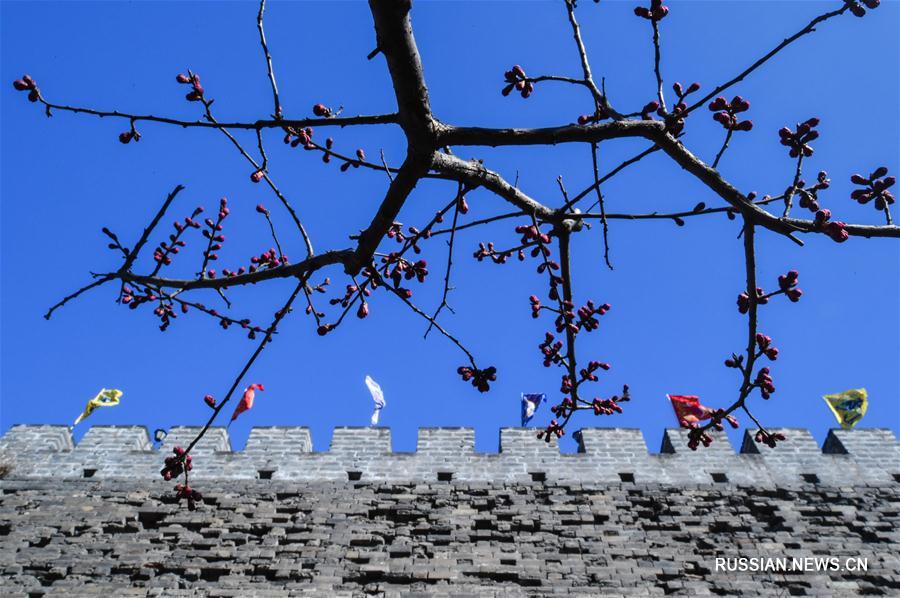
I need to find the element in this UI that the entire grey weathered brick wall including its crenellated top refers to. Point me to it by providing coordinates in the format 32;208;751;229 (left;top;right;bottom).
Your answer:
0;426;900;596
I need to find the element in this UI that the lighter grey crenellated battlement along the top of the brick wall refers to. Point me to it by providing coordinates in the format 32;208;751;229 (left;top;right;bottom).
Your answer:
0;425;900;486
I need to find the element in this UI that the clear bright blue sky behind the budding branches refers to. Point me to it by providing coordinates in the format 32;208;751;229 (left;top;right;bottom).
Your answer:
0;0;900;450
